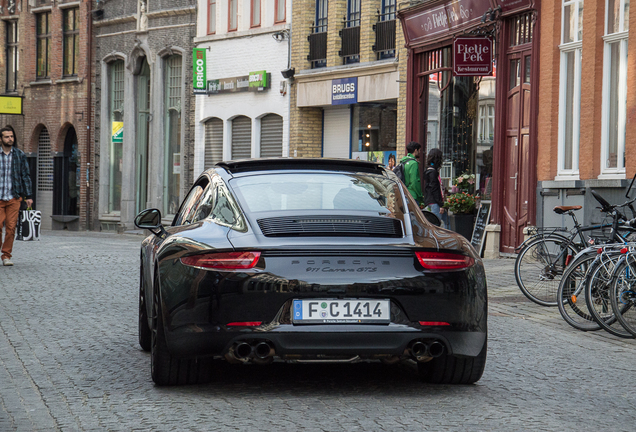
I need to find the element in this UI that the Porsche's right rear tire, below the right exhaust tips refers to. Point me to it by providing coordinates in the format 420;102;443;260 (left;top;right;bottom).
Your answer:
417;340;488;384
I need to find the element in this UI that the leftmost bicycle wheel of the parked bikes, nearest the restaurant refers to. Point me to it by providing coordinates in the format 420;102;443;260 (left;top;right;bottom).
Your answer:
515;236;578;306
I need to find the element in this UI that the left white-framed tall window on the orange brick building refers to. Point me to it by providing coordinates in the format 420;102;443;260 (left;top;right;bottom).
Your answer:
557;0;583;177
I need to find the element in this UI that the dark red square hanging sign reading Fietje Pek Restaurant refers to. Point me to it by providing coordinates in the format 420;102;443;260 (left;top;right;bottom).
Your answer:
453;37;492;76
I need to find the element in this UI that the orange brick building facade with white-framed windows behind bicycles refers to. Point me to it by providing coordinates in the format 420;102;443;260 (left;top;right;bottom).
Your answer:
537;0;636;230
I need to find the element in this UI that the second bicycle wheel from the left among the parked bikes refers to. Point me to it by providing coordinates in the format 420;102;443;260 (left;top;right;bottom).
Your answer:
557;252;601;331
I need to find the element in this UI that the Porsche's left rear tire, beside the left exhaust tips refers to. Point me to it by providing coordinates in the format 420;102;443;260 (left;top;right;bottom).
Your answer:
150;277;212;386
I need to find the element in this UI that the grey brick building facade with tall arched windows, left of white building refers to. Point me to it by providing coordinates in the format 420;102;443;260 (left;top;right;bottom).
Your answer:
93;0;197;231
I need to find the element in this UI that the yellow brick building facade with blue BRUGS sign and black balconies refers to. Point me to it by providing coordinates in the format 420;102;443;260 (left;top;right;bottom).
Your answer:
290;0;406;164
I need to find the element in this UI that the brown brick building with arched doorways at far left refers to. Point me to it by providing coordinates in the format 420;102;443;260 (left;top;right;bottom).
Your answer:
0;0;95;230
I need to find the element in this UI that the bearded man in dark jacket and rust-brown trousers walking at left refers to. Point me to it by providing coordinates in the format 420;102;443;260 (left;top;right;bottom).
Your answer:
0;126;33;266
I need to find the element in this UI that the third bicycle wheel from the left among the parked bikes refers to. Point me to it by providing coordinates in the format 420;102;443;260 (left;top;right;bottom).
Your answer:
585;252;634;338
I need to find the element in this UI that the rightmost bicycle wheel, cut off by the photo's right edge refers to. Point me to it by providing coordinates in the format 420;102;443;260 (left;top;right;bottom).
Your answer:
610;257;636;336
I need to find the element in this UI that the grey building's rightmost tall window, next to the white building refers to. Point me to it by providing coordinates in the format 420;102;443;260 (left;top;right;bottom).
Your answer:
163;55;183;214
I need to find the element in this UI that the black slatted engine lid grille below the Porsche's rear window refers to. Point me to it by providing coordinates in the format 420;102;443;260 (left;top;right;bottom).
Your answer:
256;216;402;238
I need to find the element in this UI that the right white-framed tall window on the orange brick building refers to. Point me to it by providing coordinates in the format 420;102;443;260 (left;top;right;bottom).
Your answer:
601;0;629;176
